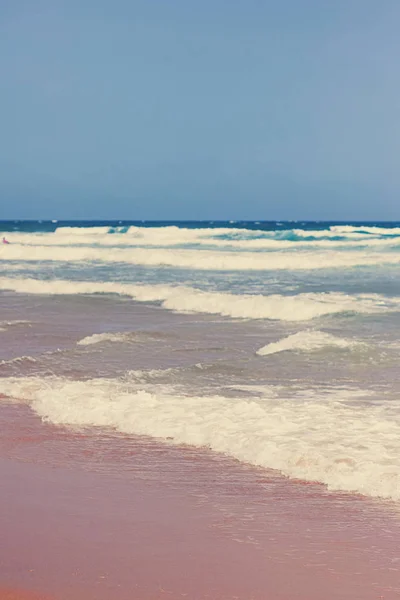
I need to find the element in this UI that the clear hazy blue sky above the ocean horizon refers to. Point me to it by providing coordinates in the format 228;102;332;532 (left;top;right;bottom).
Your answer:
0;0;400;220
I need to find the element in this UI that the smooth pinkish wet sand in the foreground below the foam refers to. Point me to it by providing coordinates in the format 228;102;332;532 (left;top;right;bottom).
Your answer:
0;401;400;600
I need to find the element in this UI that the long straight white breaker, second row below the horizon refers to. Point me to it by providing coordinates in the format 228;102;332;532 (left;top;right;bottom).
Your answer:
1;244;400;271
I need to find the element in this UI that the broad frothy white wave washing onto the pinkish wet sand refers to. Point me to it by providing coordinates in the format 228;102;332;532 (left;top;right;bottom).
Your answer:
1;377;400;500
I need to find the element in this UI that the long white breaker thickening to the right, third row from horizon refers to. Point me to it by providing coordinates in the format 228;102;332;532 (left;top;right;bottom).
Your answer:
0;278;400;321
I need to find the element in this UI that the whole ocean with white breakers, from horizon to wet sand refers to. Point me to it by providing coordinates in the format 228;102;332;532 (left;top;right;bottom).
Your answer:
0;221;400;598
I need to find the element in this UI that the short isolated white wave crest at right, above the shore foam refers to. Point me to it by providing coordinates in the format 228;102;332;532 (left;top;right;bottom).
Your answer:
256;329;365;356
